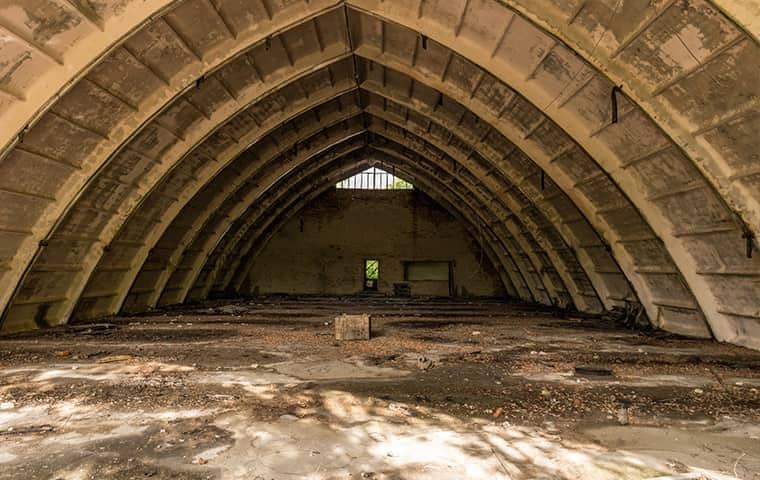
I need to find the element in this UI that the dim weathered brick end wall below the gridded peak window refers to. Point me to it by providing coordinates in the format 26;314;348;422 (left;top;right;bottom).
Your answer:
247;190;504;296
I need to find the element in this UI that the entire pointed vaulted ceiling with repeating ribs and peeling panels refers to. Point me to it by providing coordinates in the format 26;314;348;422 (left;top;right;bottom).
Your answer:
0;0;760;348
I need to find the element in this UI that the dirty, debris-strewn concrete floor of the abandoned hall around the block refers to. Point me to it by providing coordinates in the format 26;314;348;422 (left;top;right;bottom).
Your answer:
0;298;760;480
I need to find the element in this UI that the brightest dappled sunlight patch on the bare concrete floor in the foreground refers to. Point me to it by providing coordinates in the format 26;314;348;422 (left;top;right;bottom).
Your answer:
230;390;666;480
